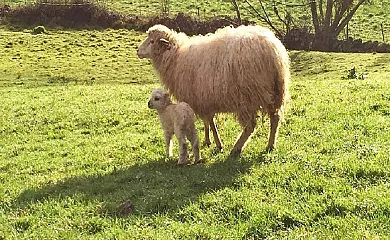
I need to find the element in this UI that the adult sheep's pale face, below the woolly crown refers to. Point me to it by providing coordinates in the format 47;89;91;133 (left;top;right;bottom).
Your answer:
137;31;171;59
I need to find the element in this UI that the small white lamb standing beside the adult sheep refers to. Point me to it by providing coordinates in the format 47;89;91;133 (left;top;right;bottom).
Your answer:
148;88;200;165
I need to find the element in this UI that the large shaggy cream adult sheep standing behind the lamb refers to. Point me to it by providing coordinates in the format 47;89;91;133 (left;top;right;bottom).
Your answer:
137;25;290;155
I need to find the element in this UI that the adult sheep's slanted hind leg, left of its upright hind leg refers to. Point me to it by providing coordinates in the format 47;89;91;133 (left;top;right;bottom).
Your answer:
230;114;256;156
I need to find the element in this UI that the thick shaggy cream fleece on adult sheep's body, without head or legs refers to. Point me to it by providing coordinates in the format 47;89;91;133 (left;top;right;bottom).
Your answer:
163;27;286;115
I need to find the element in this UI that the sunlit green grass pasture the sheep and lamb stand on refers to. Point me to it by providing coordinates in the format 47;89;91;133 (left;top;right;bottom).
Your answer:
0;25;390;239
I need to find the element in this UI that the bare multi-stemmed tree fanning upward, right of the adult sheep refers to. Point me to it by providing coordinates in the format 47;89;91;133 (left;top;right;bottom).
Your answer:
310;0;367;50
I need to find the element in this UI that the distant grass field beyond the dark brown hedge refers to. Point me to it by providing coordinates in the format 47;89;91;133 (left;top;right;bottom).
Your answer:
0;0;390;43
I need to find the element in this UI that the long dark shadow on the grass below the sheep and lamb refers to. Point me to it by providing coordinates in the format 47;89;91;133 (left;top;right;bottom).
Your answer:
14;155;264;217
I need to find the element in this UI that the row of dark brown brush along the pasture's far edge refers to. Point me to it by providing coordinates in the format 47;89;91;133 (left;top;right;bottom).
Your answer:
0;0;390;53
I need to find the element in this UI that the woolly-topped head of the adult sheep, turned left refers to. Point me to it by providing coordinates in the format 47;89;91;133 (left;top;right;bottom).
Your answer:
137;25;176;59
